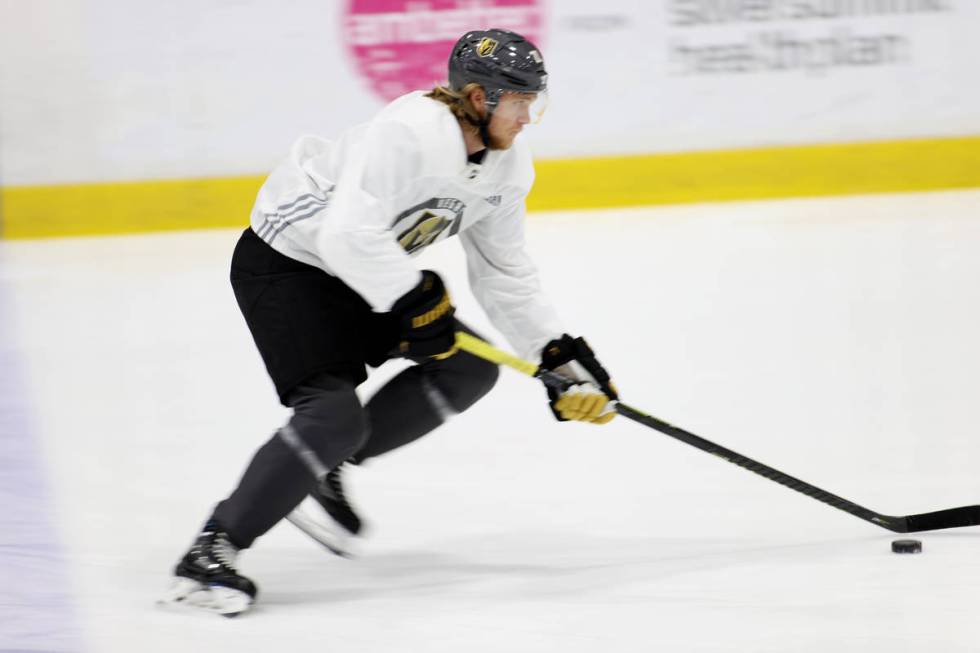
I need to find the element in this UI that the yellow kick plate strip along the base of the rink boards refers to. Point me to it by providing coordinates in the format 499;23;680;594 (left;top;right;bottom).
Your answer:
0;136;980;238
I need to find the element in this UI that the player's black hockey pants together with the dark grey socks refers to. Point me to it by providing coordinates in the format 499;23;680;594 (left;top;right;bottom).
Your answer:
214;229;498;547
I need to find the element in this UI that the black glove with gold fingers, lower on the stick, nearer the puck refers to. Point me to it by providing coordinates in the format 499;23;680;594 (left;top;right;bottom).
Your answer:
541;333;619;424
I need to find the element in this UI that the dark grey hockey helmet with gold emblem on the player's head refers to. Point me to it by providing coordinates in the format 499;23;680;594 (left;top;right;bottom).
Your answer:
449;29;548;112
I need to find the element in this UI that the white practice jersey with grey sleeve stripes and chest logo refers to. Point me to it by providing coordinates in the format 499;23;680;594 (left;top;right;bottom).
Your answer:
251;91;564;360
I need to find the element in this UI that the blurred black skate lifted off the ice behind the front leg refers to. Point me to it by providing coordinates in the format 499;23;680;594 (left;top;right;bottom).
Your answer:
286;463;363;557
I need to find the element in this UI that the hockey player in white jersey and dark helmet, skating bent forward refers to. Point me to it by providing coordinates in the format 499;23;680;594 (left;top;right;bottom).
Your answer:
165;29;616;615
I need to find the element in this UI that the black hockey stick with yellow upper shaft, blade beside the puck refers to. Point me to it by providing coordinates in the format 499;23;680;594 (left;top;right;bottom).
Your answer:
456;332;980;533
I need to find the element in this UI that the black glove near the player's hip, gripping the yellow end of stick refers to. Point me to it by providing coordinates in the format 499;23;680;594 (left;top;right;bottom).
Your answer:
391;270;456;358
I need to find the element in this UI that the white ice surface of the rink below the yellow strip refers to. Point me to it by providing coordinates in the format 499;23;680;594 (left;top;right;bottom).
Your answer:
0;191;980;653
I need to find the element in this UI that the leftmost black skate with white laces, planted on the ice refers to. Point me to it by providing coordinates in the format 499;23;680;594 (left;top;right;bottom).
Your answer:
161;519;258;617
